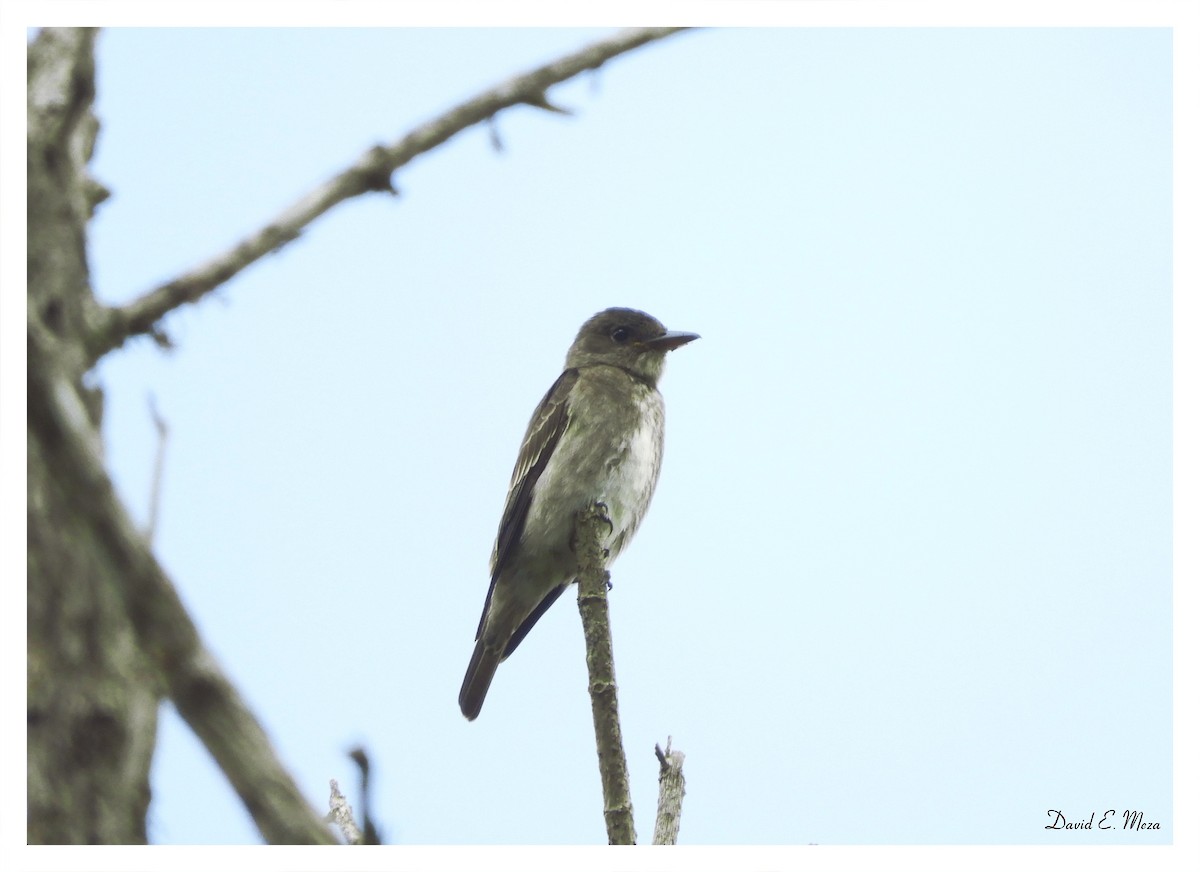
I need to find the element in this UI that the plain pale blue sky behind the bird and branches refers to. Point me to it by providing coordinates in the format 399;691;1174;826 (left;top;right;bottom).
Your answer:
28;23;1172;844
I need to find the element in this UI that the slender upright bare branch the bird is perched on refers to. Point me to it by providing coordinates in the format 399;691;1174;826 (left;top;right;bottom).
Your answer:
575;504;637;844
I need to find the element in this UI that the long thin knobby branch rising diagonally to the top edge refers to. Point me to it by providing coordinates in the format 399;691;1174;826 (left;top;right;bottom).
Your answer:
86;28;685;362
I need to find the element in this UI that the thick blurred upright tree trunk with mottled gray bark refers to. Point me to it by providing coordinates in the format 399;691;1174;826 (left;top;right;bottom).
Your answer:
26;30;161;844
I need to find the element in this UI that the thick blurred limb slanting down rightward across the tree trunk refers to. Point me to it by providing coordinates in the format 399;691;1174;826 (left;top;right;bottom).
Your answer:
28;313;334;844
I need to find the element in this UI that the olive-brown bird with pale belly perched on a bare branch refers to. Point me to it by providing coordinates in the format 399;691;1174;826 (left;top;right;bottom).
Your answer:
458;308;700;721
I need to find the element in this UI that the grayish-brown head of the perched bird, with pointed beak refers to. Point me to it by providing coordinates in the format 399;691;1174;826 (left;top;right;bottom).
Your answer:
566;308;700;385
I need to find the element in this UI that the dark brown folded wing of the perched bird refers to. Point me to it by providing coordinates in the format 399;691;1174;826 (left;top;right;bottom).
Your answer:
475;369;580;639
